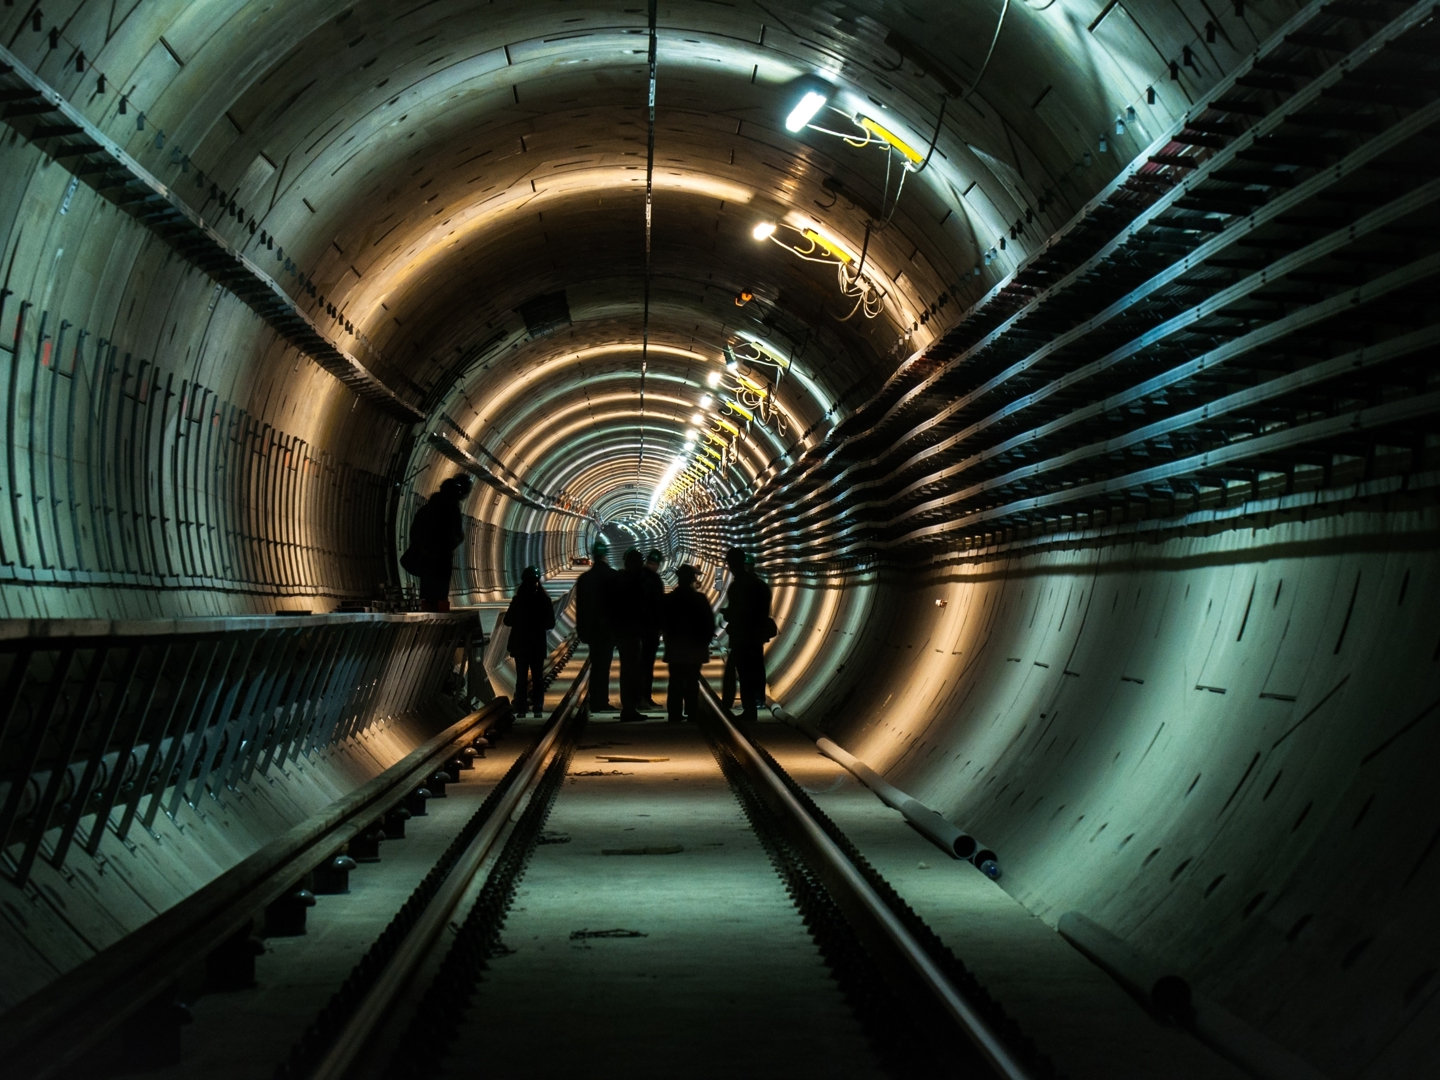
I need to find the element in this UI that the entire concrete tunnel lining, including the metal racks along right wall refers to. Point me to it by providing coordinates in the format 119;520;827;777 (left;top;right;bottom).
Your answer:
0;0;1440;1077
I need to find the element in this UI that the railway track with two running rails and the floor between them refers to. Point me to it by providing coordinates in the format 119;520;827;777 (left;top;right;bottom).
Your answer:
253;664;1058;1080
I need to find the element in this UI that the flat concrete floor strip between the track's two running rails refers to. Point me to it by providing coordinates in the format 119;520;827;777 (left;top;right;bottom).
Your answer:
445;720;883;1079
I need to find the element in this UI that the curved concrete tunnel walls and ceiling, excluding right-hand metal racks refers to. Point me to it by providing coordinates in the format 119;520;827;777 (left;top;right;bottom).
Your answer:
0;0;1440;1074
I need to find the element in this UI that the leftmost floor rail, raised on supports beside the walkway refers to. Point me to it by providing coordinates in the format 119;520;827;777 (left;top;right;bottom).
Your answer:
0;700;510;1080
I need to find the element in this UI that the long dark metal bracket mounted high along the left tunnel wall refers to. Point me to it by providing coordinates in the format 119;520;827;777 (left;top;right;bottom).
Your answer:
0;48;425;423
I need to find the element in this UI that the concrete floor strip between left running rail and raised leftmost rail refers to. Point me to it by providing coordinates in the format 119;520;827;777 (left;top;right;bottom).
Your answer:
145;720;541;1080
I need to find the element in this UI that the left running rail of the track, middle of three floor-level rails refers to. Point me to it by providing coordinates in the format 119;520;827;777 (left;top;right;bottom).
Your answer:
310;660;590;1080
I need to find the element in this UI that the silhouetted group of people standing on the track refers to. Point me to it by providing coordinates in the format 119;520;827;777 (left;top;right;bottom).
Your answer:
504;540;775;721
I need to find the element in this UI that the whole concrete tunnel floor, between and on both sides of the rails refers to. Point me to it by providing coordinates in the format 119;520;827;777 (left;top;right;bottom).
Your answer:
126;651;1240;1080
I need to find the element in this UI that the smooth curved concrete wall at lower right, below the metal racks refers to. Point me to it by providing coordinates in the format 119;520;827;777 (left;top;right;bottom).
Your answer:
772;501;1440;1076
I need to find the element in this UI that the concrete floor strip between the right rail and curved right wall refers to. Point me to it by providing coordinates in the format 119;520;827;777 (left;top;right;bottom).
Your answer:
744;723;1244;1080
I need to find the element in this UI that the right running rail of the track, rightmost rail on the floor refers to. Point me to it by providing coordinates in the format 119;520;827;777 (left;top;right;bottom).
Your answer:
700;683;1032;1080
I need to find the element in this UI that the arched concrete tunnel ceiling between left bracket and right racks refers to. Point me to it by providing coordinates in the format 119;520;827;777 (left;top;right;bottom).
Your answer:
0;0;1307;527
